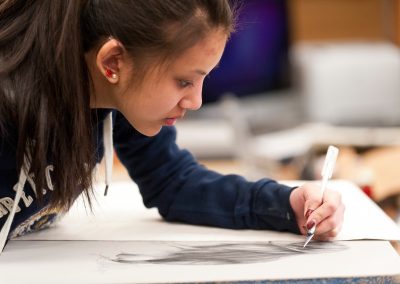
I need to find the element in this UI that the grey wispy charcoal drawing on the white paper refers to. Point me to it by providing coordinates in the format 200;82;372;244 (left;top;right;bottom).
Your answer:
108;241;347;265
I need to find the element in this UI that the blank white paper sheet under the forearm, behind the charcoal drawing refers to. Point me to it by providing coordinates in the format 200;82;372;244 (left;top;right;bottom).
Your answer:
16;180;400;241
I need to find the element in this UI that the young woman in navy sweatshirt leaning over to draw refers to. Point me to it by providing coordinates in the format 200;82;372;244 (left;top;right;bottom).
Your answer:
0;0;344;253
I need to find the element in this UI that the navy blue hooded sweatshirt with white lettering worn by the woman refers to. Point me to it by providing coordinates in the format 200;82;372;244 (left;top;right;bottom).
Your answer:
0;110;299;240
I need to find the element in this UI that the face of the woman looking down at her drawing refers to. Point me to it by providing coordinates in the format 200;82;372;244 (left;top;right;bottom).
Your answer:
115;31;227;136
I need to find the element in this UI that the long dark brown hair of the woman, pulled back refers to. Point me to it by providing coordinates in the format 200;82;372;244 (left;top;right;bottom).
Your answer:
0;0;234;209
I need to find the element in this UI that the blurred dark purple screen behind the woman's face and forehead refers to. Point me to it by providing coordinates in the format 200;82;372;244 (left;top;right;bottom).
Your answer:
203;0;289;102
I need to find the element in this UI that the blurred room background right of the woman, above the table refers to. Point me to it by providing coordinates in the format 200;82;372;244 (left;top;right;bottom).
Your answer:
114;0;400;244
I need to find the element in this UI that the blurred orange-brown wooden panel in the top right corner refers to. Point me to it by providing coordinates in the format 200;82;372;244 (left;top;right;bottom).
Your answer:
288;0;400;42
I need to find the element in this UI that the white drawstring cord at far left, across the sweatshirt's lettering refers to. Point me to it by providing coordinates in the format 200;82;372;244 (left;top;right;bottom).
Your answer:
0;157;29;254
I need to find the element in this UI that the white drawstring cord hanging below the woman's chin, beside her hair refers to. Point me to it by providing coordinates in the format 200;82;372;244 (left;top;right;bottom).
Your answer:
103;112;114;195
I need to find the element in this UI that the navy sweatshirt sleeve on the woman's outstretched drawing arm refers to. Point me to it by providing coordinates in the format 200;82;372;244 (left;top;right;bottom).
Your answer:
114;113;299;233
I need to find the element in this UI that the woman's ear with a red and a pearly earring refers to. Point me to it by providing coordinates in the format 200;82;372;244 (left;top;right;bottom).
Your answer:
96;39;124;84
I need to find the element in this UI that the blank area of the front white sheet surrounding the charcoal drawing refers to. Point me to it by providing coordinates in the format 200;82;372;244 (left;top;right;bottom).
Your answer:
0;241;400;284
